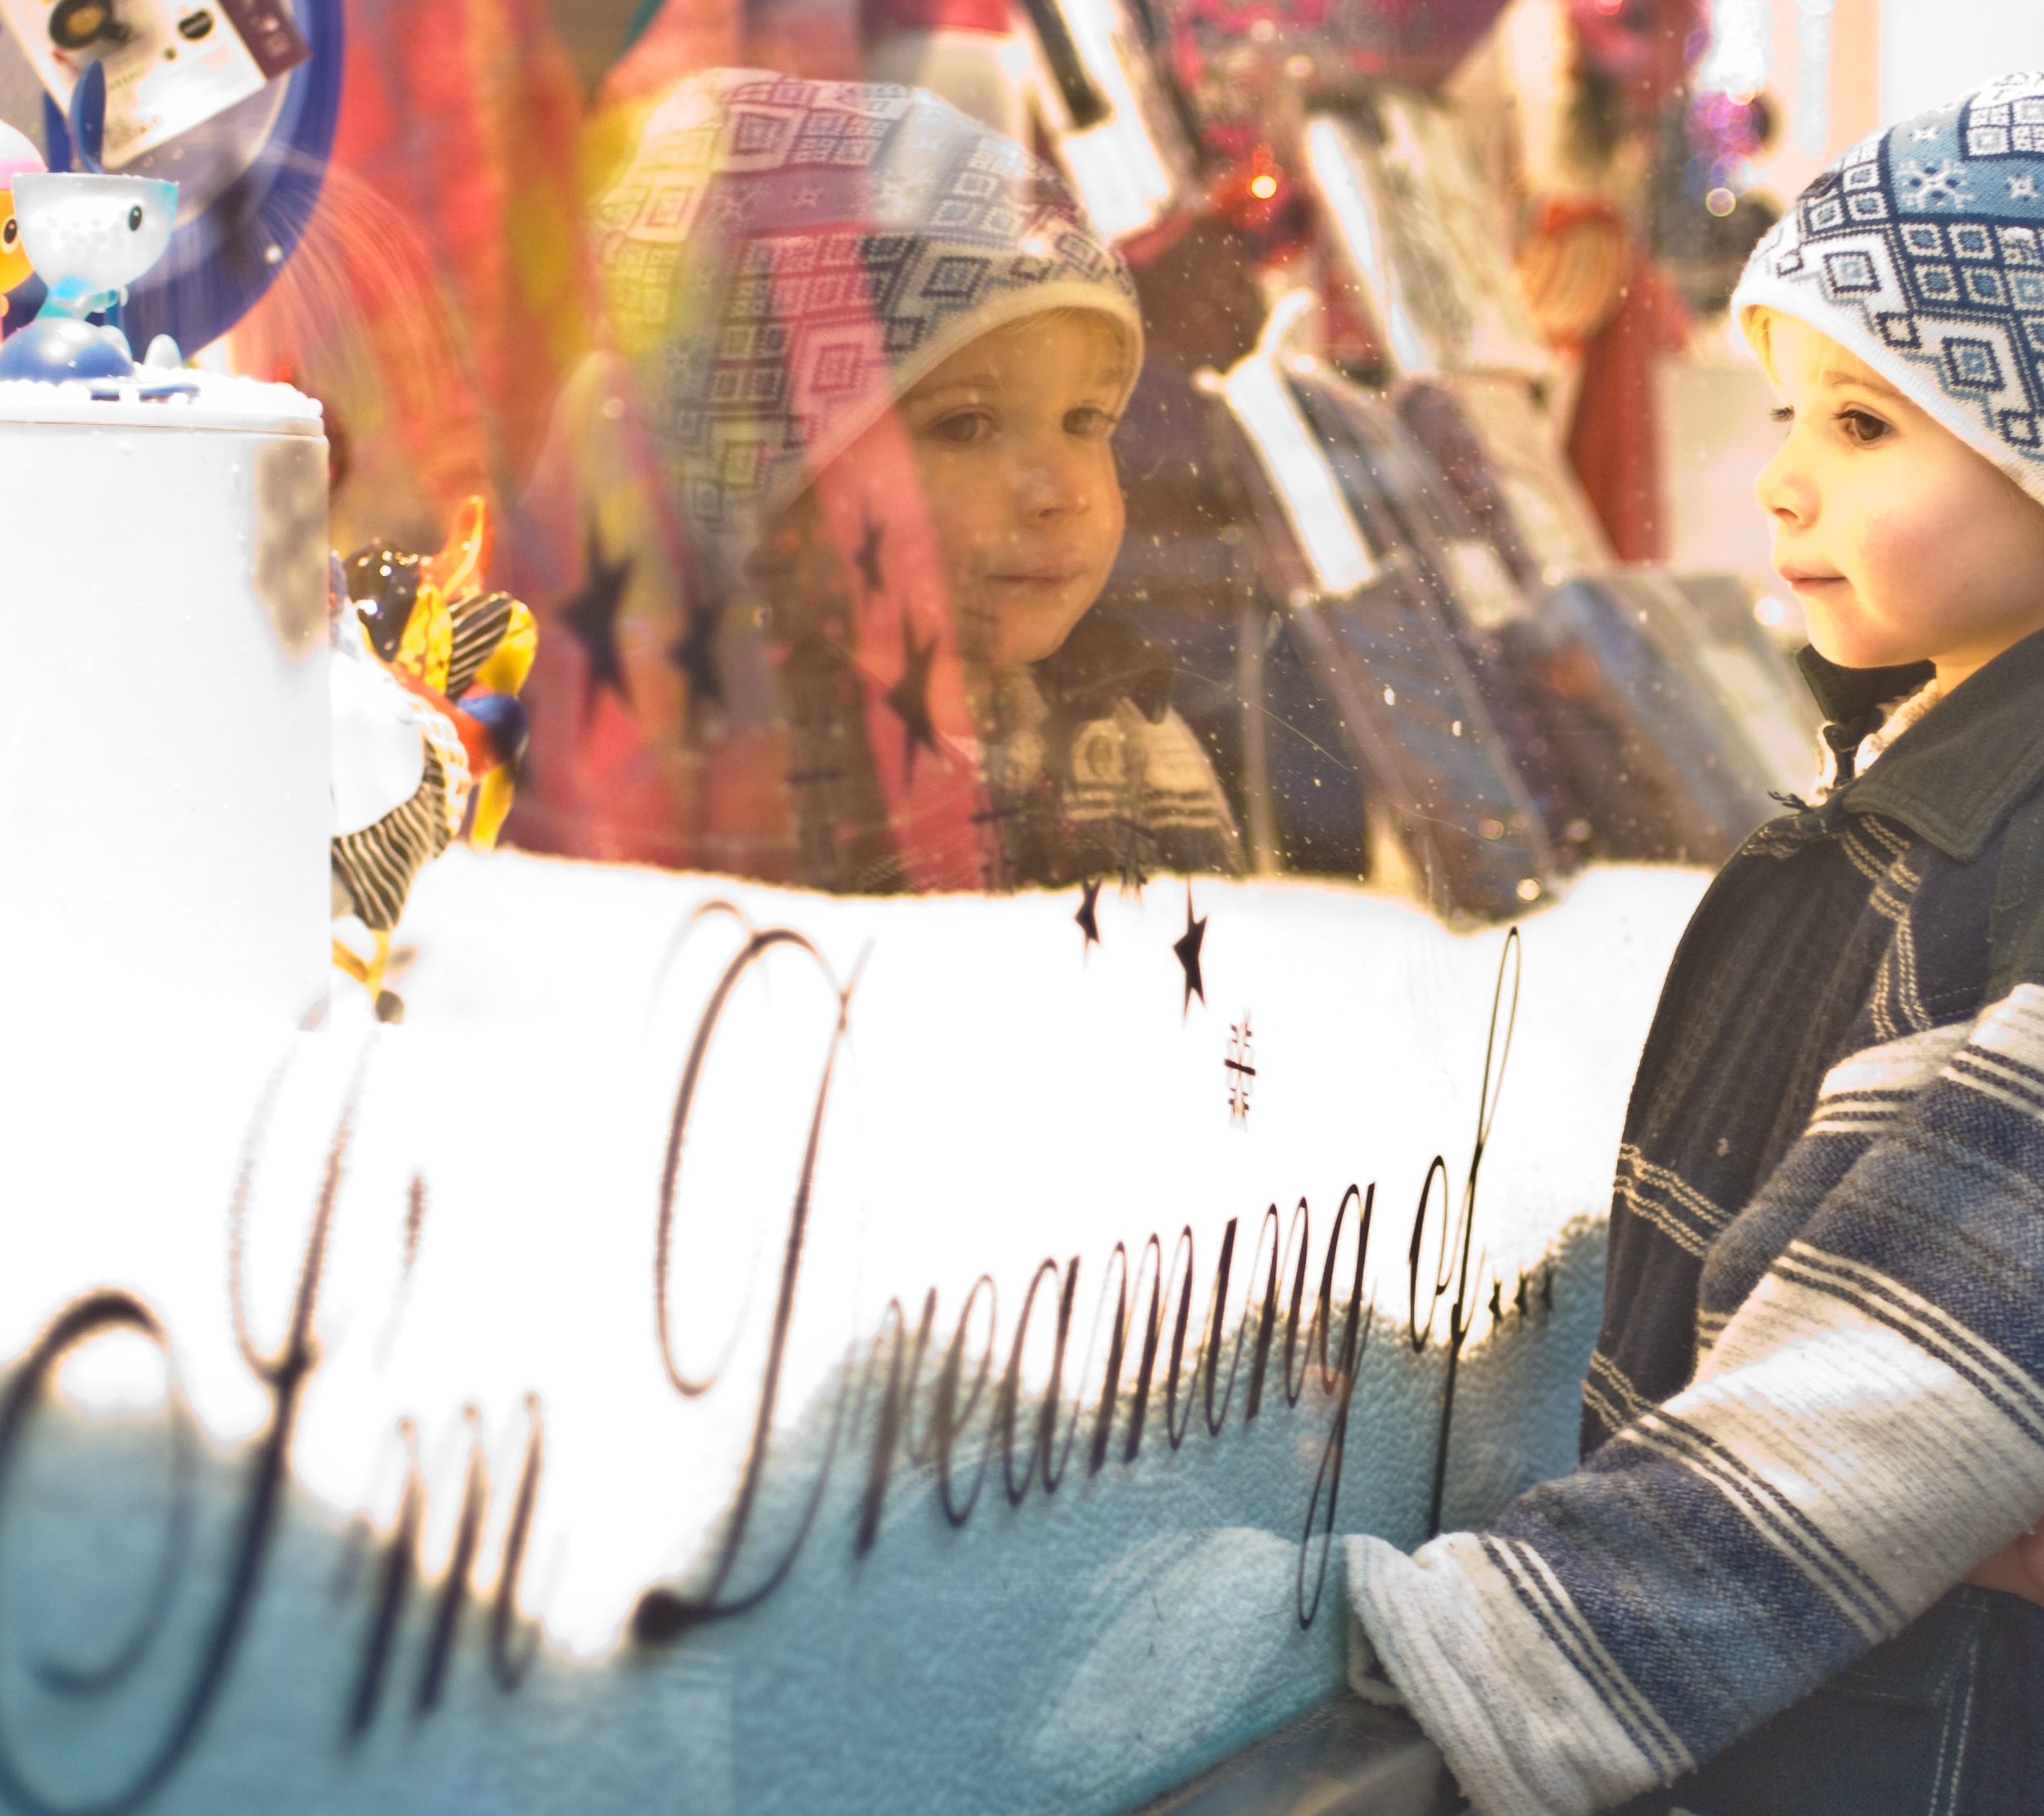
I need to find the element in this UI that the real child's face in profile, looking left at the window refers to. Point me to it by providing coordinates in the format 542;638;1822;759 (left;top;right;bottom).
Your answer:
1754;315;2044;689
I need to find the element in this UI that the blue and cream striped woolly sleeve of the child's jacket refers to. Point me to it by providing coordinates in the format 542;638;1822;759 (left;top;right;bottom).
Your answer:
1347;984;2044;1816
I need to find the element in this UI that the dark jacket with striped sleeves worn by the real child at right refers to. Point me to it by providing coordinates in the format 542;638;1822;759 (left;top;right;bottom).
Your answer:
1347;636;2044;1816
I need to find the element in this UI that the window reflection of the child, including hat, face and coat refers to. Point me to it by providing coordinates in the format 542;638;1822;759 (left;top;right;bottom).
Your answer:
535;69;1241;889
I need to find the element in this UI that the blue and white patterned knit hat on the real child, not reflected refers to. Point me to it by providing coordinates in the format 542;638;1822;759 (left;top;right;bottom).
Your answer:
1731;74;2044;503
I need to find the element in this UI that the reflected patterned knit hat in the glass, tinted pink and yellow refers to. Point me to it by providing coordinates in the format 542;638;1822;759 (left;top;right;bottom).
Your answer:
593;69;1143;572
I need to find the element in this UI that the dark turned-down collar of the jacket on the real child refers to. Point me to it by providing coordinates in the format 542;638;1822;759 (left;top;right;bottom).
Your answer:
1840;632;2044;861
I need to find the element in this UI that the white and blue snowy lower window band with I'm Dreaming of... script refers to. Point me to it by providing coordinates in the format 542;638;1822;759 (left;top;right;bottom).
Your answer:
0;851;1702;1812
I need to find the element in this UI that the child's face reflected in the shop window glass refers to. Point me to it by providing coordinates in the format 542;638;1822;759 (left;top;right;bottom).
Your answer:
899;311;1129;663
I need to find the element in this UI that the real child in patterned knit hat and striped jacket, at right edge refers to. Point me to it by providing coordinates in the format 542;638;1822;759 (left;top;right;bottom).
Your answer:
1347;76;2044;1816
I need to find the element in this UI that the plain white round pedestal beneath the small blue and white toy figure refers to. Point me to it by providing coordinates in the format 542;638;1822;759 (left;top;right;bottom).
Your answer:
0;374;331;1035
